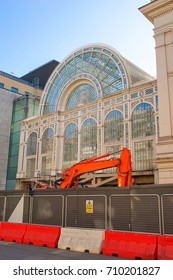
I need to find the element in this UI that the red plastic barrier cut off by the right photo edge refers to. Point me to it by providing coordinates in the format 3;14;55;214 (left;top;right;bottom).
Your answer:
157;235;173;260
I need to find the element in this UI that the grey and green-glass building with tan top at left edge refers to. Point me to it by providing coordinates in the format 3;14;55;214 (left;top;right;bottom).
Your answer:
0;71;42;189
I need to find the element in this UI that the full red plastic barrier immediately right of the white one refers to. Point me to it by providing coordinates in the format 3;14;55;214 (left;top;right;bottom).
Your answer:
102;231;157;260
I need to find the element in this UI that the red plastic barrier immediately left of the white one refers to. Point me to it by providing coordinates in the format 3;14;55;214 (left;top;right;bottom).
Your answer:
23;225;61;248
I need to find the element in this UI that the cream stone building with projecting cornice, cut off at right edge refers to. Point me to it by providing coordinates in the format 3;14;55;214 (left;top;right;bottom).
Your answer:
140;0;173;184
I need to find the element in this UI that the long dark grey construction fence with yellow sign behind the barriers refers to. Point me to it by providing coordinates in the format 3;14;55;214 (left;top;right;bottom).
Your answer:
0;185;173;235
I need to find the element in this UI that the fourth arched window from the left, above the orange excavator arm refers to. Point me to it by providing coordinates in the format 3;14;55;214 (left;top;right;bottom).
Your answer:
80;118;97;160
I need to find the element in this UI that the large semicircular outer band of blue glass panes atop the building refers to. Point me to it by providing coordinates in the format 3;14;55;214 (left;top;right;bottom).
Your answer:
42;47;128;115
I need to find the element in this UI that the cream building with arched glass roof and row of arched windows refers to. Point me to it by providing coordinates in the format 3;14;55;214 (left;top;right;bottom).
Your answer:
17;44;159;188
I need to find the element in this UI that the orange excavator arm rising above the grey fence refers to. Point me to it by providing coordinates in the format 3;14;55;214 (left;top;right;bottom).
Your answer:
54;148;132;189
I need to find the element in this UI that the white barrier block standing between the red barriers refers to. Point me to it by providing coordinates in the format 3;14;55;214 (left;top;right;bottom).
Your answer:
58;228;104;254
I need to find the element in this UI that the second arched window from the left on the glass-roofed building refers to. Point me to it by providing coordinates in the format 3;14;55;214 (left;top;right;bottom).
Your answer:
41;128;54;175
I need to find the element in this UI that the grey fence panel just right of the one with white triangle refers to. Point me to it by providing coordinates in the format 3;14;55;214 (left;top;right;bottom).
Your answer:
32;195;64;226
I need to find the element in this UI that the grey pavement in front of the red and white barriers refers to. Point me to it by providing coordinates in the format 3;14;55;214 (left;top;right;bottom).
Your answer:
0;241;120;260
